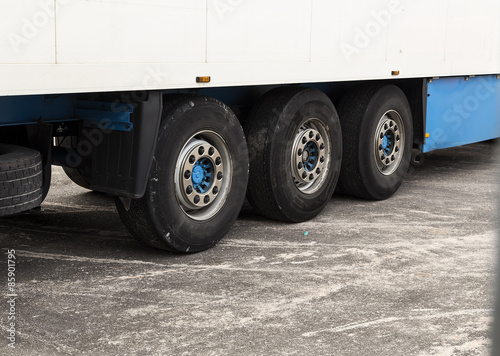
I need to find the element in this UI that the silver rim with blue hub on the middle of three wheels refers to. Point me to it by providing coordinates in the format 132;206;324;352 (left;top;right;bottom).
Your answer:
291;118;332;194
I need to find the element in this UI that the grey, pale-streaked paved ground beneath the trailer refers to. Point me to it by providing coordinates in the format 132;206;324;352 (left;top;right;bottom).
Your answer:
0;143;500;356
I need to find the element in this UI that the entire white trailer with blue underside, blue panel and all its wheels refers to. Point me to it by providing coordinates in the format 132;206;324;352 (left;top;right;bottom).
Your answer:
0;0;500;253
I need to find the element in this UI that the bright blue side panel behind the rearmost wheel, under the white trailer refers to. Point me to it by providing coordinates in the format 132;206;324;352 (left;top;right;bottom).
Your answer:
423;75;500;152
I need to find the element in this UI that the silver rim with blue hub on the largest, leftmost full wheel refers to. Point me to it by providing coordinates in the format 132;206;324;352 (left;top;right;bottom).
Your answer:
175;130;232;221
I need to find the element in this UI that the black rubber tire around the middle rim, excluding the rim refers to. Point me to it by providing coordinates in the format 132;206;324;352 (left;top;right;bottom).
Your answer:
245;86;342;222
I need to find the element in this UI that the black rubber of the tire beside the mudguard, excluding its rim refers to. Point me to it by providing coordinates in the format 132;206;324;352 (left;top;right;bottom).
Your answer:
116;95;248;253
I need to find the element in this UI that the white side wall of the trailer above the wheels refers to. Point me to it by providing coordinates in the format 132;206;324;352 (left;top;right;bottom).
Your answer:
0;0;500;95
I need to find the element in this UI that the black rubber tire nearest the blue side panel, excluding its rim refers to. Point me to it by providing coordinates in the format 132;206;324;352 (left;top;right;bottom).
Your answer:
339;83;413;200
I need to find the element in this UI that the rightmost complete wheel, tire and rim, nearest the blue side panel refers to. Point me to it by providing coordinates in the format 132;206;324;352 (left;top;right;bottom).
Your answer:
339;84;413;200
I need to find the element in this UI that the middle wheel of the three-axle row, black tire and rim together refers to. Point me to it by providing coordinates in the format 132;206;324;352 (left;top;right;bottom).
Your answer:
246;86;342;222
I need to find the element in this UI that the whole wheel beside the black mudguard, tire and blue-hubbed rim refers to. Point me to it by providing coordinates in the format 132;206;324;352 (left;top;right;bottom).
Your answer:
116;95;248;253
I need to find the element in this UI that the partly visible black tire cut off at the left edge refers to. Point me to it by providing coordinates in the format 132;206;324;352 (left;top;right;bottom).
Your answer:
0;144;43;216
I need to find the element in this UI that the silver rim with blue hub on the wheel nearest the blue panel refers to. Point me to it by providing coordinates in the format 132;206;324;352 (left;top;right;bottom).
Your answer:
374;110;406;176
